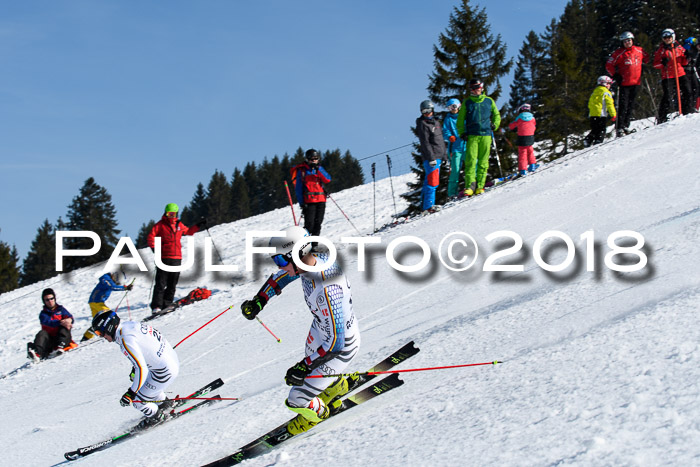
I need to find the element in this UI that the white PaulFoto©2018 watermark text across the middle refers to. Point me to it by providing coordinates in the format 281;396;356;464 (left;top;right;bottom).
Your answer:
56;230;648;273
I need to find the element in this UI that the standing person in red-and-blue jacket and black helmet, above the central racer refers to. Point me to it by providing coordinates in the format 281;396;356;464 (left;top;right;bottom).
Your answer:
292;149;331;248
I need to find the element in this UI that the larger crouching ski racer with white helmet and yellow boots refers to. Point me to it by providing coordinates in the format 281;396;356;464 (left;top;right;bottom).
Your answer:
241;226;360;434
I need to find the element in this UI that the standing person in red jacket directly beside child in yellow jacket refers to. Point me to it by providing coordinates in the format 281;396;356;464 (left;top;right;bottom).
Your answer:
605;31;649;137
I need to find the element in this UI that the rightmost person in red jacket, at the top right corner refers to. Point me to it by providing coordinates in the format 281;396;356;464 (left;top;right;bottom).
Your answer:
654;29;695;123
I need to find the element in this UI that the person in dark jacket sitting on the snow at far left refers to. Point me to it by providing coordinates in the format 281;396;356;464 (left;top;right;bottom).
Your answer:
27;289;75;361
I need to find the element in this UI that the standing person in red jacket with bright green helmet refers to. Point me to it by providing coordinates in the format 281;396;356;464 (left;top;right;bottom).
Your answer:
147;203;206;314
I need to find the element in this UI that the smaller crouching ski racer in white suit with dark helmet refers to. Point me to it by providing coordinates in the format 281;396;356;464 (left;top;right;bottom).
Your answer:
92;310;180;427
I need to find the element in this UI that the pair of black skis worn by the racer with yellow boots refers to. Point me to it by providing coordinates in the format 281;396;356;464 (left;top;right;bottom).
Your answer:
200;341;420;467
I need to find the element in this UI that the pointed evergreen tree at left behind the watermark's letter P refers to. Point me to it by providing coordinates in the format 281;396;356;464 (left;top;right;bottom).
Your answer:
64;177;121;271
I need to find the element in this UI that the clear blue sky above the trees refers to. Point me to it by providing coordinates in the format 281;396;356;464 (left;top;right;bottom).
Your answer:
0;0;566;260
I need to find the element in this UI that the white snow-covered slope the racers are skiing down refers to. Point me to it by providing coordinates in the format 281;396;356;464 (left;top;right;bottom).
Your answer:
0;116;700;466
